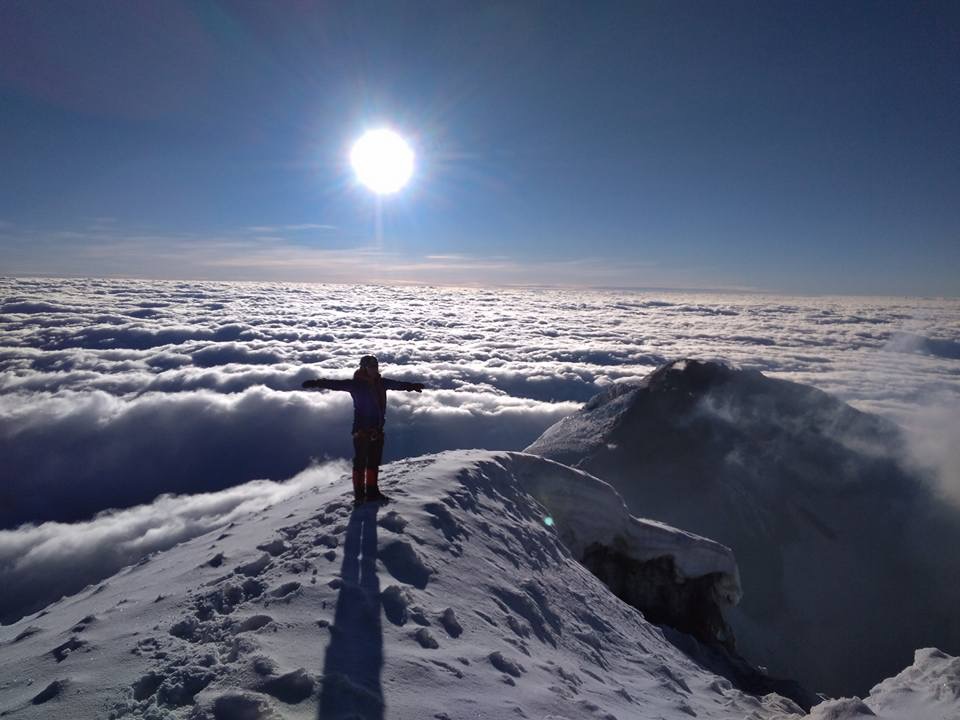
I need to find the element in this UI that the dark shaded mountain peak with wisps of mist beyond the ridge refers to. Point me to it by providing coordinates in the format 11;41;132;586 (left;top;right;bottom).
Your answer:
527;360;960;695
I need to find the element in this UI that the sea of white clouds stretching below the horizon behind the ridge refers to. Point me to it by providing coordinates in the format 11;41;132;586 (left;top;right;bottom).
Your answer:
0;278;960;620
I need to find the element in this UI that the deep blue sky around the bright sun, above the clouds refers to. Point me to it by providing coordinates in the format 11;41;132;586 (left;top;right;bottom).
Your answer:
0;0;960;296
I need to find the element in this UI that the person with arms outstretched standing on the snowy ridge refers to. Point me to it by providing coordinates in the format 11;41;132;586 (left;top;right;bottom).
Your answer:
303;355;426;507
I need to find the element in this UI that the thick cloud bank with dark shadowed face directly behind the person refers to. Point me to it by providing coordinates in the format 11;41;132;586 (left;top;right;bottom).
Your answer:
0;386;577;527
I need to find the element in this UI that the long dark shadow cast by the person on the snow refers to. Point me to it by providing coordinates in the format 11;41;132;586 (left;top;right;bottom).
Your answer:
317;503;384;720
